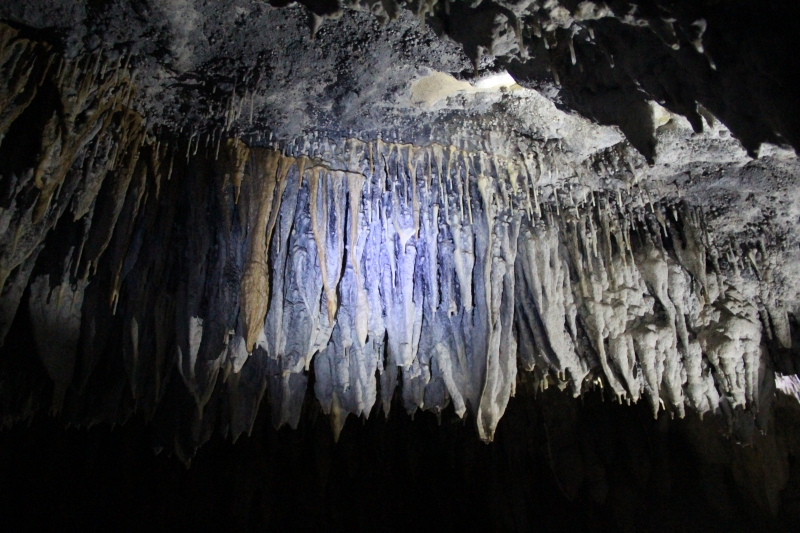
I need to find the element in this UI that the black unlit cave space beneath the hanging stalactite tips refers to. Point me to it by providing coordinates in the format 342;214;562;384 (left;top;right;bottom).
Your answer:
0;382;800;532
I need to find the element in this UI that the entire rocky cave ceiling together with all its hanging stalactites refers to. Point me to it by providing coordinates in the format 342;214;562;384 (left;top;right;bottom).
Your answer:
0;0;800;530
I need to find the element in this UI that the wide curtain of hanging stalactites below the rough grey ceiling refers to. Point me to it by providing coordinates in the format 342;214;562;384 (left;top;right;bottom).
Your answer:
0;22;791;457
